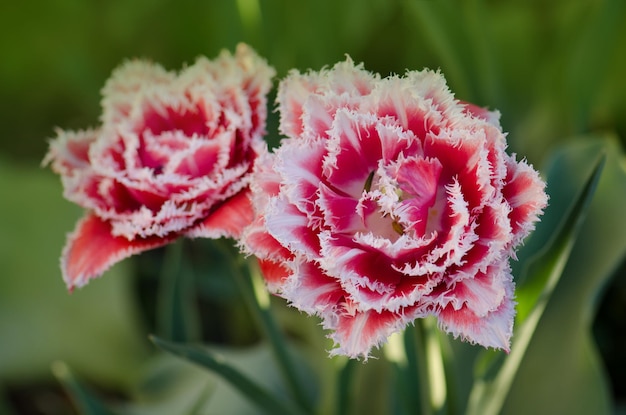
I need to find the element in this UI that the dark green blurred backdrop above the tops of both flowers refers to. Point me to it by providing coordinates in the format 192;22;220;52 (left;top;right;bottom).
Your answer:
0;0;626;161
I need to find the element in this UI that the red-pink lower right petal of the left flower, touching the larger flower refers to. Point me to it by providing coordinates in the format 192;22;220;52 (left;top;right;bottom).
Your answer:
185;190;254;238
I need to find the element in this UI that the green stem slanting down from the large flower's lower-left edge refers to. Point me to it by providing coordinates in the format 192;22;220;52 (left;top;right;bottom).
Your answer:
235;261;313;413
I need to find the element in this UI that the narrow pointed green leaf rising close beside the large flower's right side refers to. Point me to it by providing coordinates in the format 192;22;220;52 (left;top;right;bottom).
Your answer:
468;138;605;415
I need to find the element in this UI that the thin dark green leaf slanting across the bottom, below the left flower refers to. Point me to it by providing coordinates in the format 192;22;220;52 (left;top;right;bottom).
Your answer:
151;336;302;415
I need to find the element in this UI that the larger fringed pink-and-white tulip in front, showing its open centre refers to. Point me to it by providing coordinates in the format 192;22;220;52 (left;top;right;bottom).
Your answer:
243;59;547;357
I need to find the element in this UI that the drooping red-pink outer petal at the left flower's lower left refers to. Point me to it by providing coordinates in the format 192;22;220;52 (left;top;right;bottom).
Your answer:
61;214;177;291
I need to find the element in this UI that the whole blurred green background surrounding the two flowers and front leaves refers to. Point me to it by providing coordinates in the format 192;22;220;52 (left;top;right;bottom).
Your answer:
0;0;626;414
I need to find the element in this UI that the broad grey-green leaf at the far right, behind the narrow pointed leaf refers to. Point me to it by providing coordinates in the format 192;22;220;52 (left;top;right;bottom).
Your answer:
494;136;626;415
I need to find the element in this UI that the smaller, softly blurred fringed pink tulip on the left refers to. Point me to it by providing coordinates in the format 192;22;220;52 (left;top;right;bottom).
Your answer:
44;45;274;290
